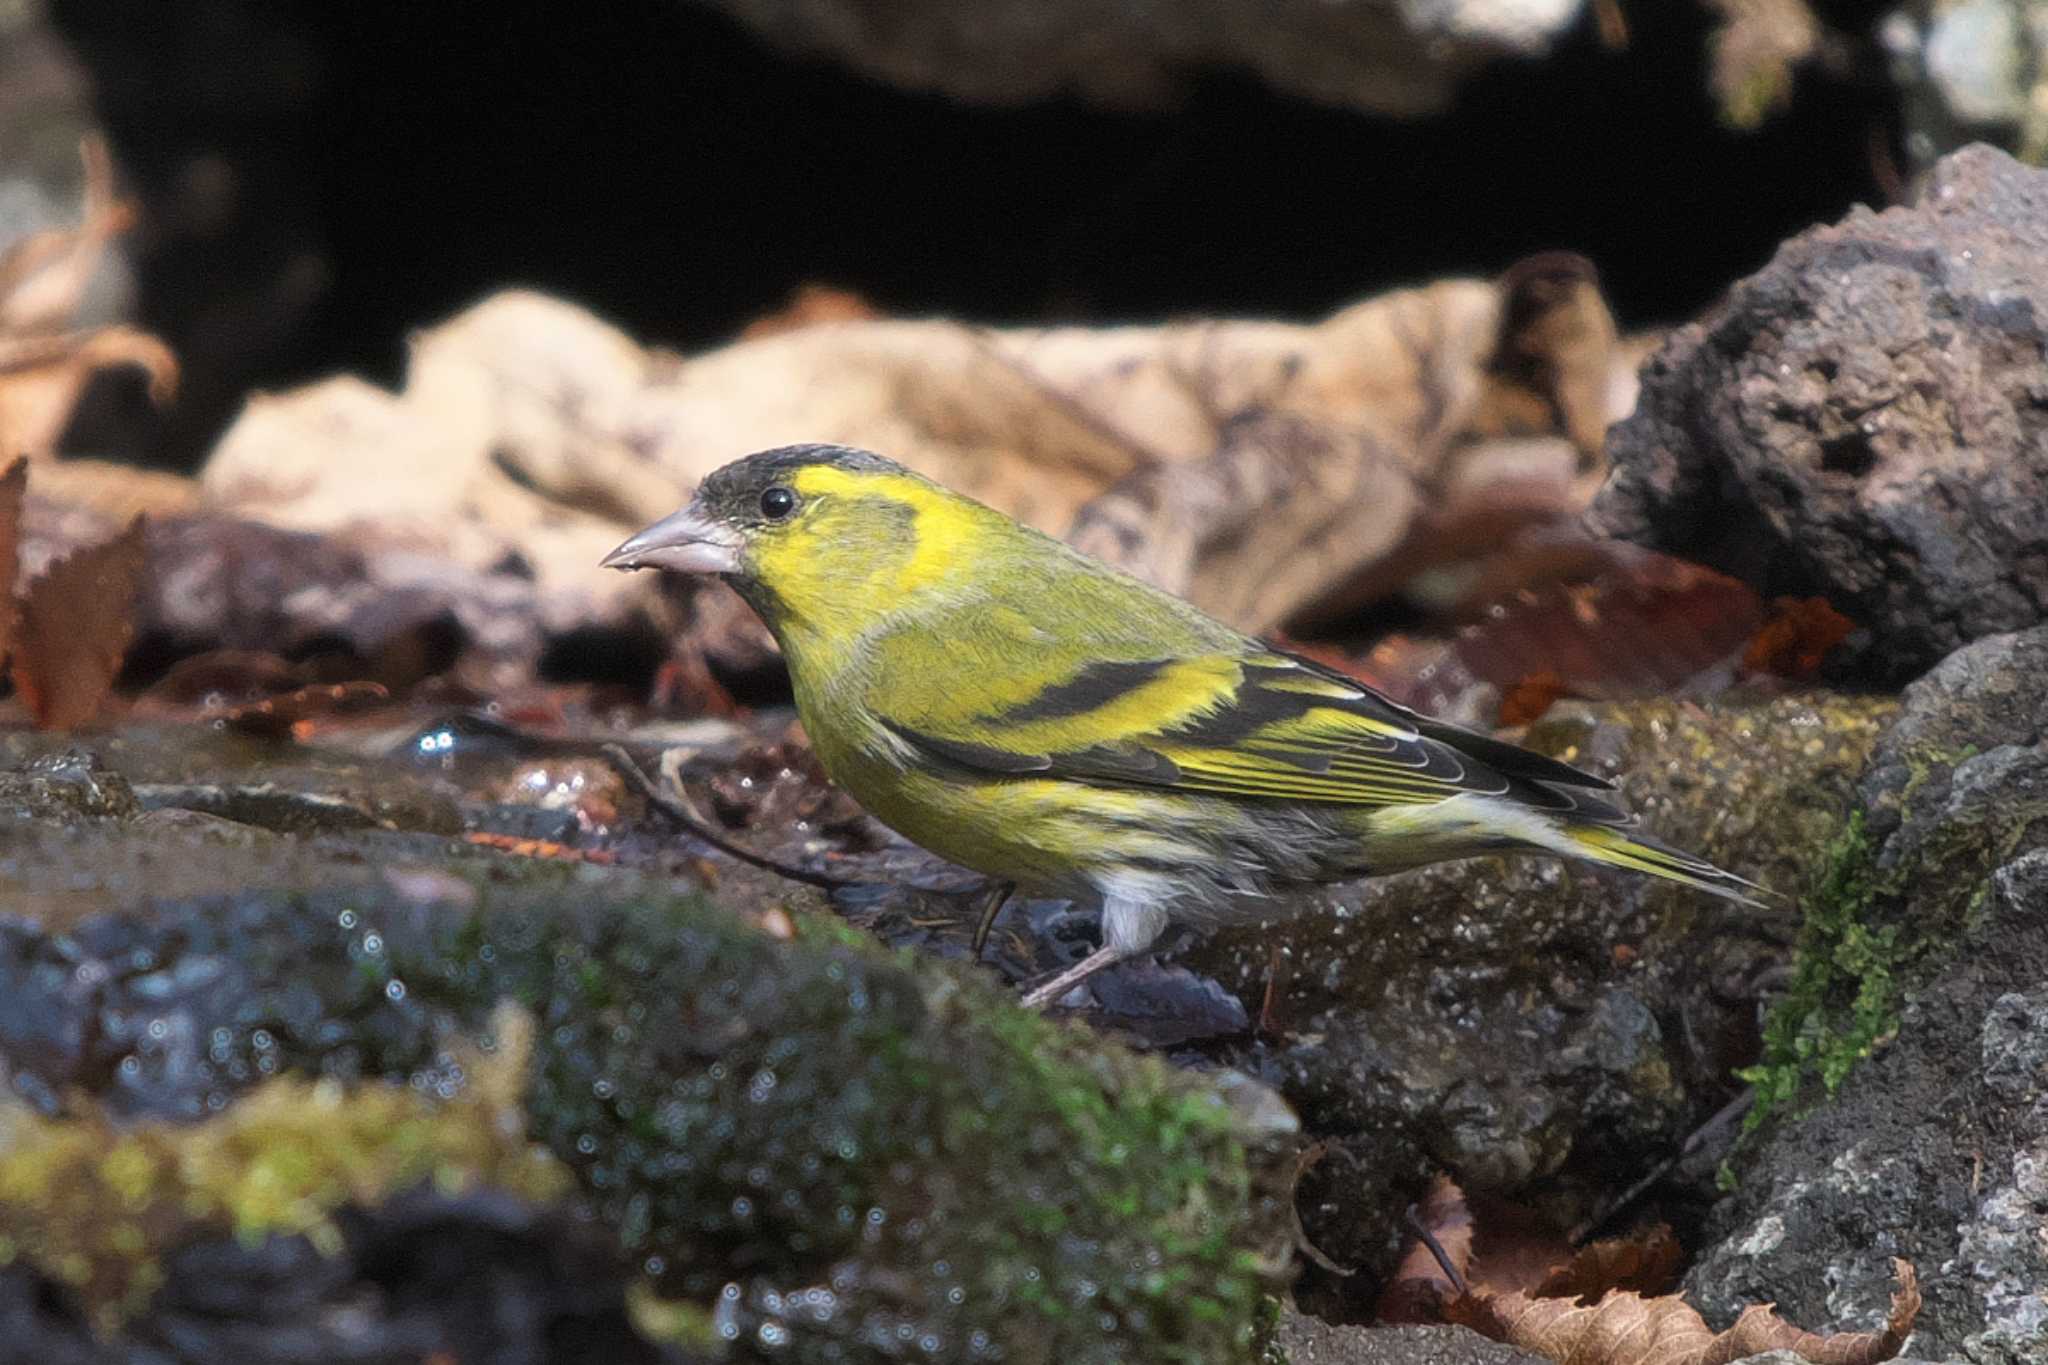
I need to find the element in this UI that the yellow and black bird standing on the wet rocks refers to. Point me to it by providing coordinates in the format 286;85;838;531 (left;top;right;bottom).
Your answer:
604;446;1755;1005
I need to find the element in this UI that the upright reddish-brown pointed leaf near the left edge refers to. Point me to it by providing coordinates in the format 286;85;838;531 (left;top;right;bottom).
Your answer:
10;518;145;731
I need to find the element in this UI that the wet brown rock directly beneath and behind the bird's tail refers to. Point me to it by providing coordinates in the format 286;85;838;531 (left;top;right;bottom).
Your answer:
1188;700;1890;1316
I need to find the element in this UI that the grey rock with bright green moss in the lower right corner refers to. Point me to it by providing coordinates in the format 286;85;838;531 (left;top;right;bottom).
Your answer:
1688;630;2048;1365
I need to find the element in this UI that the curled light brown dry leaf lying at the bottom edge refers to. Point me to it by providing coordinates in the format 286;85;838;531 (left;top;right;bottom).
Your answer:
1444;1261;1921;1365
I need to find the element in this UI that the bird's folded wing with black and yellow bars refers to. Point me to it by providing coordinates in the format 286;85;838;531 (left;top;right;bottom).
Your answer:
883;651;1624;823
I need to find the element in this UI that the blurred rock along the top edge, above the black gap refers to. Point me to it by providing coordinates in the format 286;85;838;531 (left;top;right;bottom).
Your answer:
671;0;1583;115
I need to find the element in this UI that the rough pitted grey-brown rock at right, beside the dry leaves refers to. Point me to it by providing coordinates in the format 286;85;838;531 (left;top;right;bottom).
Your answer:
1591;145;2048;684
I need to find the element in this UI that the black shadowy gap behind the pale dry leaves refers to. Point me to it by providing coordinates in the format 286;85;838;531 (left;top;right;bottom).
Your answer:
24;0;1898;469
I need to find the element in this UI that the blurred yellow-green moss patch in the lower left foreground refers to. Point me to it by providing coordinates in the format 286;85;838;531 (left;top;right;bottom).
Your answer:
0;1013;571;1332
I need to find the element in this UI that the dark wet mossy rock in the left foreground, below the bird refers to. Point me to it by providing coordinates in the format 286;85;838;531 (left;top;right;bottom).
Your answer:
0;853;1290;1363
